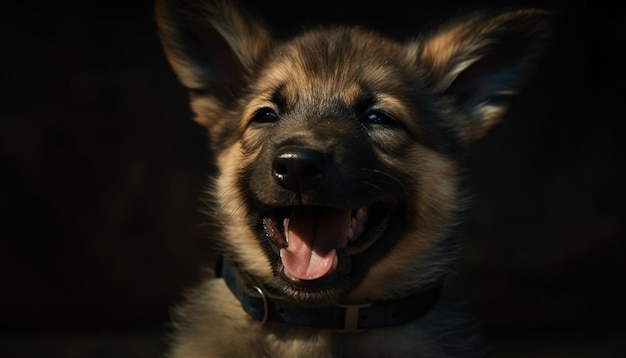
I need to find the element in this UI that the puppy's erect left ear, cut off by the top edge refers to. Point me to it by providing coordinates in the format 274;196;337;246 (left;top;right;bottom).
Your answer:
156;0;271;124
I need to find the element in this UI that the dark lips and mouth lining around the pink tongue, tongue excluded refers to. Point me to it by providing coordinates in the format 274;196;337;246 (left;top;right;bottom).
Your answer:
263;202;393;287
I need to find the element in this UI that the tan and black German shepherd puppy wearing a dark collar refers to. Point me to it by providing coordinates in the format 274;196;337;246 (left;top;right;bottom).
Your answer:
156;0;551;358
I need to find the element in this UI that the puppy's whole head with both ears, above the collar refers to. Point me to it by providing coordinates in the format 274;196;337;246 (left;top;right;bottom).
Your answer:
157;1;549;303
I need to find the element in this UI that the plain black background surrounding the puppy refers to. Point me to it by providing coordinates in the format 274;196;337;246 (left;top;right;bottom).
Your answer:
0;0;626;357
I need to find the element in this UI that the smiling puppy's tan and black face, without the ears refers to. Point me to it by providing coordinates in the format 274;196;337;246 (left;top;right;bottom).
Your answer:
224;30;458;301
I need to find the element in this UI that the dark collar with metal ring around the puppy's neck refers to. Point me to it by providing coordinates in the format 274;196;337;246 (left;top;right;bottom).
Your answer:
216;260;441;332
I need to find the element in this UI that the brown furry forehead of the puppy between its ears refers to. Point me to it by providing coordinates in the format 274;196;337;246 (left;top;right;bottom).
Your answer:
250;29;408;105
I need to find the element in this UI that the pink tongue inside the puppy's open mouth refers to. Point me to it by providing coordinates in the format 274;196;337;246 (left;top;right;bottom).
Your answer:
280;206;351;280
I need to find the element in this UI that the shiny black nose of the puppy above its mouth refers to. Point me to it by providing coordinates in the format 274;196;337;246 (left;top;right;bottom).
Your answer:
272;147;324;194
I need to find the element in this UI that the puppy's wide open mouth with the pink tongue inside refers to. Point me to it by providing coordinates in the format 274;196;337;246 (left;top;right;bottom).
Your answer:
263;202;391;285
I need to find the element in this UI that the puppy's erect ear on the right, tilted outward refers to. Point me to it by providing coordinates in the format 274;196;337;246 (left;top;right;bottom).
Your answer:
420;9;552;142
